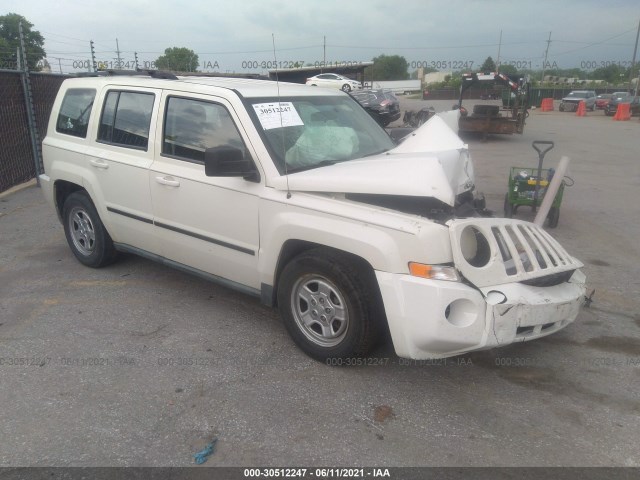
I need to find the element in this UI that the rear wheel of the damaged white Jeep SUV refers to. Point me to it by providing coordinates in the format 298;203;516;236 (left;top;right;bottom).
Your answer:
62;192;117;268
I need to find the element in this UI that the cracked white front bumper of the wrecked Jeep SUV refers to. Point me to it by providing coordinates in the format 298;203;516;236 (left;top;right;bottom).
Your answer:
376;270;585;360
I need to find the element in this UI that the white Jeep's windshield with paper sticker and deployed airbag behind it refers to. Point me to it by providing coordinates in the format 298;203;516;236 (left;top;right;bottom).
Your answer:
249;95;395;174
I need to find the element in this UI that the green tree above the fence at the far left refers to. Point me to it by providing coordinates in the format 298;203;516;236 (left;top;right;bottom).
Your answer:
0;13;46;71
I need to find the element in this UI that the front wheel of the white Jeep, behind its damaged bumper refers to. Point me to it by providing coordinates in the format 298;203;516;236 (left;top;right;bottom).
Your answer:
278;249;381;362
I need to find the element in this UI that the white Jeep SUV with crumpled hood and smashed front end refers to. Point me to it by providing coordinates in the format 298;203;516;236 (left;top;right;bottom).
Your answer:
40;75;585;360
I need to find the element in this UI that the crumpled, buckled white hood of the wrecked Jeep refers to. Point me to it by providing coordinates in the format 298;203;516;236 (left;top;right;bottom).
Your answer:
273;116;474;206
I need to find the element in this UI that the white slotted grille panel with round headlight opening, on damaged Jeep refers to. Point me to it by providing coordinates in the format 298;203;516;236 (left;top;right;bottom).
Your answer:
449;218;582;287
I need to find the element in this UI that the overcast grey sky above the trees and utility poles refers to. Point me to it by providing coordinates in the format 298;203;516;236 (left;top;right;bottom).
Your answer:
5;0;640;72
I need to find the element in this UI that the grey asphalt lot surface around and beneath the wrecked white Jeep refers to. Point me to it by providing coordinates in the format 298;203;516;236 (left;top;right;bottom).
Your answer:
0;99;640;467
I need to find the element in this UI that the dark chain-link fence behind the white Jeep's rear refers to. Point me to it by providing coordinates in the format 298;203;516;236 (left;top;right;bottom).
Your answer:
0;70;68;192
